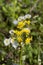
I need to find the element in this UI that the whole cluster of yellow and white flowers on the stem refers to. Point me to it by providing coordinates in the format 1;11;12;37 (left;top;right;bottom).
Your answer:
4;15;32;49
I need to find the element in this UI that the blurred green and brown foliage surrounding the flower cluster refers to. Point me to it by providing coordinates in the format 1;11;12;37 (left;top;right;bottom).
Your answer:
0;0;43;65
